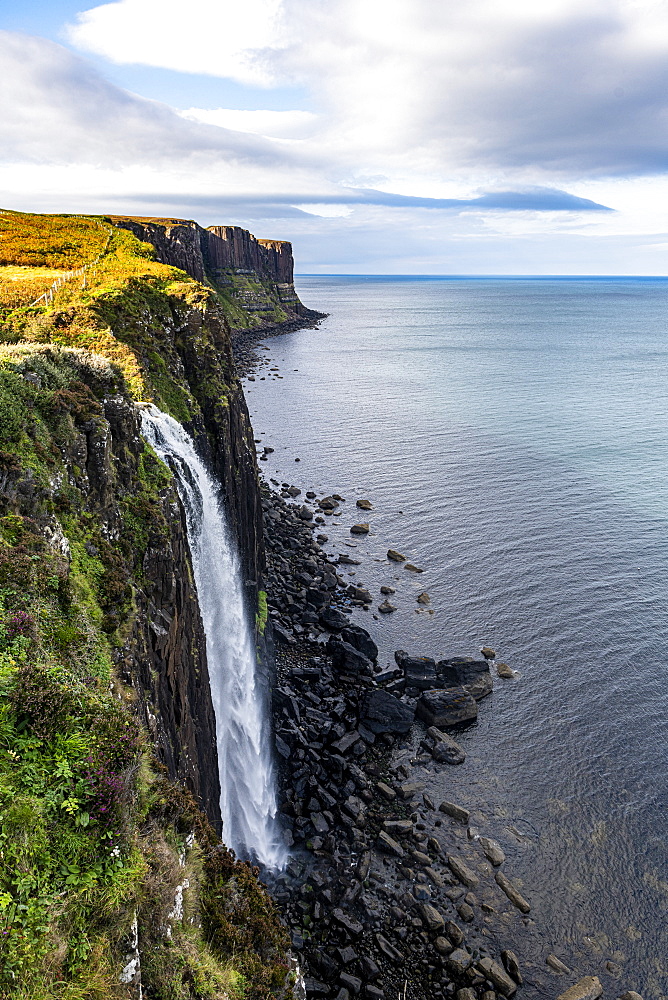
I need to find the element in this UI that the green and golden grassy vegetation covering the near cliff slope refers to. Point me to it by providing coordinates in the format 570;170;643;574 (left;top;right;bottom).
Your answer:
0;213;285;1000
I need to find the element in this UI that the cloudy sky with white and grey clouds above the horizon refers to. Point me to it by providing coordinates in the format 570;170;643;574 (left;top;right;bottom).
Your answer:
0;0;668;275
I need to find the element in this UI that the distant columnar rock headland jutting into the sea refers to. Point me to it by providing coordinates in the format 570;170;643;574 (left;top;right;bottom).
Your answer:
110;216;322;334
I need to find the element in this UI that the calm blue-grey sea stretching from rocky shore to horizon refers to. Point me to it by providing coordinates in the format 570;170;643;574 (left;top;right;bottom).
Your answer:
247;277;668;1000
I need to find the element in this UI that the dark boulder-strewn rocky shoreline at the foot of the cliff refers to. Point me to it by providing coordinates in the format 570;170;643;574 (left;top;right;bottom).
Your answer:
234;334;637;1000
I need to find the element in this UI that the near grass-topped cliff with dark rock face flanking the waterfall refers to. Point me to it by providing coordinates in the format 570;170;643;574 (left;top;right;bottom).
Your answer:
0;207;287;1000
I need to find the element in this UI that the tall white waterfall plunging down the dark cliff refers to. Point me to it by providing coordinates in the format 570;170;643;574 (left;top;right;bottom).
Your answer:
142;406;287;869
